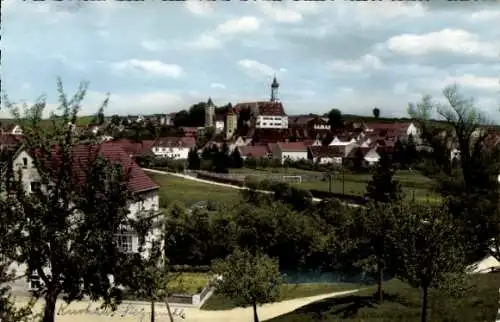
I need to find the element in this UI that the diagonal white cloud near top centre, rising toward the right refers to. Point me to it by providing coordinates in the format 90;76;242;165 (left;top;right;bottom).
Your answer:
187;16;260;49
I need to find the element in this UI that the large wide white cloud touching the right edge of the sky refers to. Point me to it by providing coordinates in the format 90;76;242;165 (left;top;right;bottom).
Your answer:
386;28;500;57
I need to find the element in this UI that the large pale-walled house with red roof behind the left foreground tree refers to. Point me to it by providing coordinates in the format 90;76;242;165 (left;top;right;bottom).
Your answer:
7;144;160;291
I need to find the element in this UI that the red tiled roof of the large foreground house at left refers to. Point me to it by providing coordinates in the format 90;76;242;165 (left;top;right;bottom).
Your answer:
33;143;159;193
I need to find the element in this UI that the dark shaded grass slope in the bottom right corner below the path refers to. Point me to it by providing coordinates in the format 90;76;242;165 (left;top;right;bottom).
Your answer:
269;274;500;322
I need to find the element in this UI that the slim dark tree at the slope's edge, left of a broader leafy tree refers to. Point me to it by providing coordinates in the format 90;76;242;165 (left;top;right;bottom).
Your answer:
355;203;395;301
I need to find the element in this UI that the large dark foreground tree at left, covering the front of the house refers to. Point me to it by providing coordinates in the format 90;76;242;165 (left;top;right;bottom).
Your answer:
0;79;143;322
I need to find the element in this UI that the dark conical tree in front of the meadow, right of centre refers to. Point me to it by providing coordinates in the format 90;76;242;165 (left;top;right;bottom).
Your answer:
365;152;401;203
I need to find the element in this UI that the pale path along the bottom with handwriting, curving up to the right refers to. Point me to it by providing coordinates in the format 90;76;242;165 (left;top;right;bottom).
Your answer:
17;289;359;322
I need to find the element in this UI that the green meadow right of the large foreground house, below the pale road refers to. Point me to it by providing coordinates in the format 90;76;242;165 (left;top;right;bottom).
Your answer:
148;172;240;207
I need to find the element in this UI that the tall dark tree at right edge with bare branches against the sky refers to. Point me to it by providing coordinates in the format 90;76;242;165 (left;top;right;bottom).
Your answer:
408;85;500;261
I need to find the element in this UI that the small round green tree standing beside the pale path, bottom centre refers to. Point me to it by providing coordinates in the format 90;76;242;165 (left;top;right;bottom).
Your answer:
212;250;282;322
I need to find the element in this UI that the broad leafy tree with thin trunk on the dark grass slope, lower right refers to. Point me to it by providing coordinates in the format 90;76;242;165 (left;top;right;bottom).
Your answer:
392;202;466;322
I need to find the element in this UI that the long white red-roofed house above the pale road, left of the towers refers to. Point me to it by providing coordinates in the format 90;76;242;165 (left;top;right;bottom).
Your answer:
151;137;196;160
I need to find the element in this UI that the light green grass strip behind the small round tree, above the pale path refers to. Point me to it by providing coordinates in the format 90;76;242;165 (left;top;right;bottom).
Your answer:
201;283;360;310
